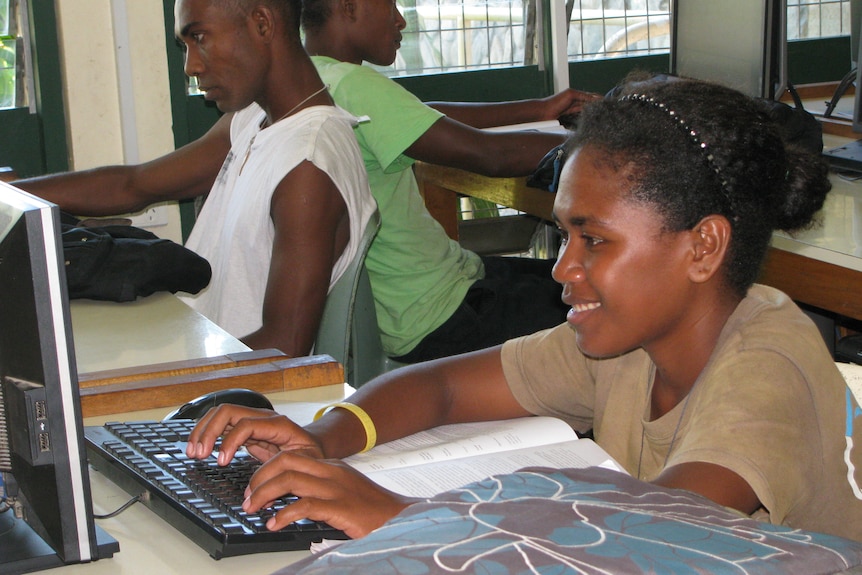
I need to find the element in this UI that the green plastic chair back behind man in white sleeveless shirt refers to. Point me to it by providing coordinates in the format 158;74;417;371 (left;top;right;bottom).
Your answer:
314;212;402;388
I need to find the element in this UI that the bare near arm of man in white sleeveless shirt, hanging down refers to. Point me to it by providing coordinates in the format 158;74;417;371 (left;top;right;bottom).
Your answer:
238;161;350;357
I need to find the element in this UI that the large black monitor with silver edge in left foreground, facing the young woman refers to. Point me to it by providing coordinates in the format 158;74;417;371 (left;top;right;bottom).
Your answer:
0;182;119;574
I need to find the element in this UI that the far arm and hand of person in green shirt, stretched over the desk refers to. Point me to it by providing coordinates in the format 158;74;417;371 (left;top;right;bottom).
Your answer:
427;88;601;128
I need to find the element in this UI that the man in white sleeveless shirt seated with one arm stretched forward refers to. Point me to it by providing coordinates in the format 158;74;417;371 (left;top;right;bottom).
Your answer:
16;0;375;356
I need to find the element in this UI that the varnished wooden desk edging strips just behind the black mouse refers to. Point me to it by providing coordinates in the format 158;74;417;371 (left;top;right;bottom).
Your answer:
79;352;344;417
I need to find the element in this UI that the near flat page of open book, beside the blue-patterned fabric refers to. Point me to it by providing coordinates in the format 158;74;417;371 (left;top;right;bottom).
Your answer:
366;439;623;497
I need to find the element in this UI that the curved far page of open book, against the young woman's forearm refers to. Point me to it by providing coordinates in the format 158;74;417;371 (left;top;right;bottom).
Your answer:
344;417;578;474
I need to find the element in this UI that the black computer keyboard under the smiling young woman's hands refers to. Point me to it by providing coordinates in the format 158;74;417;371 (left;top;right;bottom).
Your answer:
84;420;345;559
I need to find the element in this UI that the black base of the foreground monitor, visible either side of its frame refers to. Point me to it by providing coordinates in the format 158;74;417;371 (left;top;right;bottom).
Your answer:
0;511;120;575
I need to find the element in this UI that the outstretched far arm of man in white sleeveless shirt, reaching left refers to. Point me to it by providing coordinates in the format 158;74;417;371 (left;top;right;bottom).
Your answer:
14;114;232;216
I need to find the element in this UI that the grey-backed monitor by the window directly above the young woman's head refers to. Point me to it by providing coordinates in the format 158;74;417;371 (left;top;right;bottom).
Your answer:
670;0;787;99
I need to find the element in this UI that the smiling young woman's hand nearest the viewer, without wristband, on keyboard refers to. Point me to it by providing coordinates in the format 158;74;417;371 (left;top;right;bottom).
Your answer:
243;451;417;539
